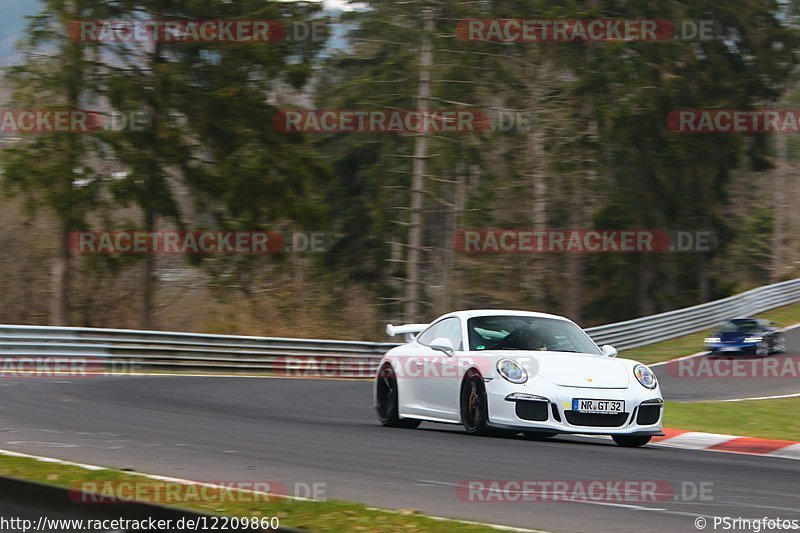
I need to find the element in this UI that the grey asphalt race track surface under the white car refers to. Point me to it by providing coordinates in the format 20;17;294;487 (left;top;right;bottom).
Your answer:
0;364;800;532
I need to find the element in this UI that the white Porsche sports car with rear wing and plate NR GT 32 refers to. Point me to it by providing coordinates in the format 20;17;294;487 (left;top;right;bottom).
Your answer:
374;310;664;446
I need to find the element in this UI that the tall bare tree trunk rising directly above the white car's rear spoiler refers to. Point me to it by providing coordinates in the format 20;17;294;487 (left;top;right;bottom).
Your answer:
405;9;434;322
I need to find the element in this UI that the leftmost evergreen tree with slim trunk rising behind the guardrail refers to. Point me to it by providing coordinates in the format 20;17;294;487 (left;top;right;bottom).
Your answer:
0;0;104;325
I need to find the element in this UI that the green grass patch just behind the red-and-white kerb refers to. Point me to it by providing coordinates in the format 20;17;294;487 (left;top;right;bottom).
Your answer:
664;398;800;441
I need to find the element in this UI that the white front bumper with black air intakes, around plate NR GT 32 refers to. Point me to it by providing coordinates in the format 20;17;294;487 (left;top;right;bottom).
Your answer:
485;378;664;435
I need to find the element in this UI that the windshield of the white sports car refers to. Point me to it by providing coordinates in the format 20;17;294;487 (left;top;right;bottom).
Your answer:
467;315;602;355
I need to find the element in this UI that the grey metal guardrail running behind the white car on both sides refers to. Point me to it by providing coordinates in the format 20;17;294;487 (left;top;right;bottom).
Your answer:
0;278;800;377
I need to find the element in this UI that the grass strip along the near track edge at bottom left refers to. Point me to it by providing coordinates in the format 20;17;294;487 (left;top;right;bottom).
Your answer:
0;456;520;533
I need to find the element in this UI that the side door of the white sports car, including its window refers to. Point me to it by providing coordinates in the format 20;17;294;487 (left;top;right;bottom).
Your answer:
417;317;464;422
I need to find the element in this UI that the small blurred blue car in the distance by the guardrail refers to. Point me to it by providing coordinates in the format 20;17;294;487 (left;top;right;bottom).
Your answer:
705;318;786;356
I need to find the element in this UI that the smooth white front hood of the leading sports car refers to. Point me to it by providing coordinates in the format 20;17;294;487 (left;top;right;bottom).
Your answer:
488;350;631;389
